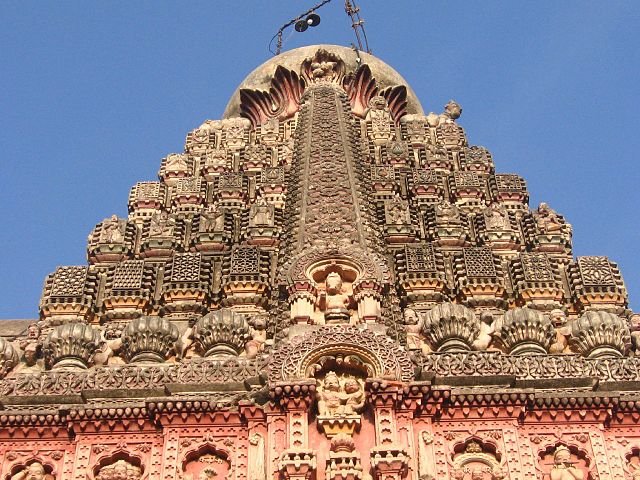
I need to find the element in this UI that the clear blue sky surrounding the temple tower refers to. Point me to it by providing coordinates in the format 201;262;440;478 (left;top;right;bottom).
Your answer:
0;0;640;318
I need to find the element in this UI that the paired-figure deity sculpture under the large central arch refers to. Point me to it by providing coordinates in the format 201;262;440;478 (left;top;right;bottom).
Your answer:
316;370;365;438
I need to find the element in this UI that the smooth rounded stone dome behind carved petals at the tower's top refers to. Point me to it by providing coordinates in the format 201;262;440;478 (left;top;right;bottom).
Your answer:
223;45;424;118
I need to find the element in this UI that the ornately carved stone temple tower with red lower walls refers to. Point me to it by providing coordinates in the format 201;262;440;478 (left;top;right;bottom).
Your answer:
0;45;640;480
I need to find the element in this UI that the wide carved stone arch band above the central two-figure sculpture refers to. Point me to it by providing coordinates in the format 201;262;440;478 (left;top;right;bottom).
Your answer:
269;325;414;383
